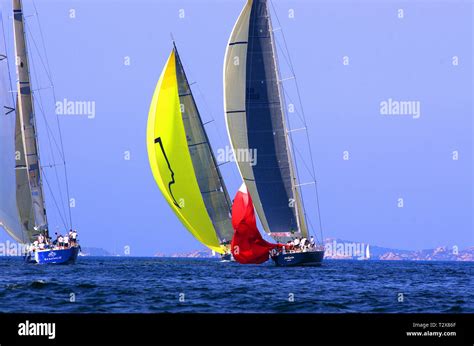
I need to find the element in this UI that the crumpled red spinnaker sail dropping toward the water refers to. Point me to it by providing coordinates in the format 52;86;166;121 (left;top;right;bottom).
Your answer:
232;184;281;264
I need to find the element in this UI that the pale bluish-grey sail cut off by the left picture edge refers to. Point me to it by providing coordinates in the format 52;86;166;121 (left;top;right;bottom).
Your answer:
0;12;28;243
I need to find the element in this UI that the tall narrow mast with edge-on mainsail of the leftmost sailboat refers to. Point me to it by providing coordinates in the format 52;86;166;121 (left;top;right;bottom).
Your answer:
13;0;48;234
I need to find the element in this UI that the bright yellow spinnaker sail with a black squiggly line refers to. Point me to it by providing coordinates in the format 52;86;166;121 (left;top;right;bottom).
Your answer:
147;49;225;253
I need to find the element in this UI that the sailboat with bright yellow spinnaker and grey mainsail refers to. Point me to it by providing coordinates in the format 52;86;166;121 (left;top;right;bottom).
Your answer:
147;42;233;260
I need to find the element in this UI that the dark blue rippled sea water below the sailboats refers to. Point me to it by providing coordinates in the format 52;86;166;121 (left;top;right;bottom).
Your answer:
0;257;474;313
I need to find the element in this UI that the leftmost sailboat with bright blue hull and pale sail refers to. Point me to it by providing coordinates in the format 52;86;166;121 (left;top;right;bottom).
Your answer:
0;0;80;264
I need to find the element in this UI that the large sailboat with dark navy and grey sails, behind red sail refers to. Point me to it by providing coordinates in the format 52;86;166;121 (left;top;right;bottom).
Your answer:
224;0;324;266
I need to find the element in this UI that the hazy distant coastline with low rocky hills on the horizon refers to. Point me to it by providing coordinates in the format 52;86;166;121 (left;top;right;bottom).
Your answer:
155;238;474;262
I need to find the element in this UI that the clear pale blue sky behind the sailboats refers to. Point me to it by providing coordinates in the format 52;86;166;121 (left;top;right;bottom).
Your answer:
0;0;474;256
